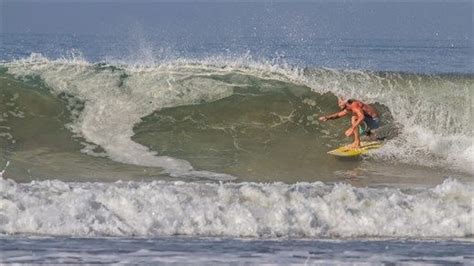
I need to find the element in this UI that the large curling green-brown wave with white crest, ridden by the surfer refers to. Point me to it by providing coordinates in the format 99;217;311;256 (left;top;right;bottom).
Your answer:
0;54;474;180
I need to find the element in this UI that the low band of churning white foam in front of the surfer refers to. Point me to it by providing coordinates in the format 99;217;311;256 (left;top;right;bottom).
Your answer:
0;179;474;238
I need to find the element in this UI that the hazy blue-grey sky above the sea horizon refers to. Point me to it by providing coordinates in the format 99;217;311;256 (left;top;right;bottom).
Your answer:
0;0;473;40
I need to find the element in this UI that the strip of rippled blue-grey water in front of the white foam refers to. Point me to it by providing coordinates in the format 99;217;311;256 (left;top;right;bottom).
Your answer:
0;237;473;265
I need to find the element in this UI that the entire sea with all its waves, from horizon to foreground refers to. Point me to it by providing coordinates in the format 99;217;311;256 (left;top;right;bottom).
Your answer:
0;1;474;264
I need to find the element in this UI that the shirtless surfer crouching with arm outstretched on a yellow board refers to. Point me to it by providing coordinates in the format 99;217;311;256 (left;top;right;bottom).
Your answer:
319;97;380;148
